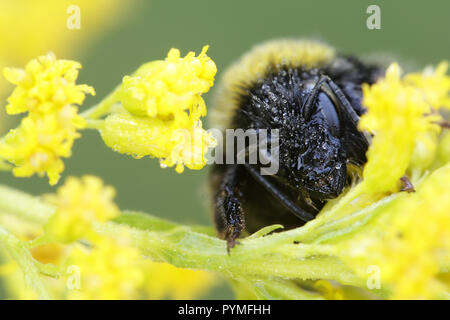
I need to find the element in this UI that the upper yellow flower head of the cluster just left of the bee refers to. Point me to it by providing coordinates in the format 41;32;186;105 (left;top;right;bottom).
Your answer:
118;46;217;120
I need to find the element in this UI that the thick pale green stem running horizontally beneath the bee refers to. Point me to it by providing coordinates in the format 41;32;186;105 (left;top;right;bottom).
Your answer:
96;223;364;286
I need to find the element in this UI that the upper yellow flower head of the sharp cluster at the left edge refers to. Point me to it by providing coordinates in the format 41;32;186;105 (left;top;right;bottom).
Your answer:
4;53;95;114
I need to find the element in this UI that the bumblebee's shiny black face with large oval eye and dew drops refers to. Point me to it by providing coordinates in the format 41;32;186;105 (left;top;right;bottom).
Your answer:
268;74;347;199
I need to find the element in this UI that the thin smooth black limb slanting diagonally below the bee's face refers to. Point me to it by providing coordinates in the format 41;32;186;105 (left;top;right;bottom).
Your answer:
245;164;314;222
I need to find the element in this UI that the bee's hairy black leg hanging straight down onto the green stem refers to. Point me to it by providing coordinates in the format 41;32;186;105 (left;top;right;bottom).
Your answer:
214;164;245;252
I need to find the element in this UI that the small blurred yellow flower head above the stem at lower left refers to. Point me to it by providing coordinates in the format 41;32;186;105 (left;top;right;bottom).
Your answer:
45;176;119;242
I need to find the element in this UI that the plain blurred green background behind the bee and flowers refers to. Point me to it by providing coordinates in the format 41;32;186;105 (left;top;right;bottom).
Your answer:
0;0;450;298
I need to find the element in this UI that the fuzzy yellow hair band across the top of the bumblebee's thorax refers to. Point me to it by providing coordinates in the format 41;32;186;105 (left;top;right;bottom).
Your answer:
210;39;335;130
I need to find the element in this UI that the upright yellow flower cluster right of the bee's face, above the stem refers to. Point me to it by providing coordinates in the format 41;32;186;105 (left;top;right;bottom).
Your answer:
359;63;450;192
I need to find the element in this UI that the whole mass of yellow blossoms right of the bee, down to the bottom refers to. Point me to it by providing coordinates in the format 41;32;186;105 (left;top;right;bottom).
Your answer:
337;63;450;299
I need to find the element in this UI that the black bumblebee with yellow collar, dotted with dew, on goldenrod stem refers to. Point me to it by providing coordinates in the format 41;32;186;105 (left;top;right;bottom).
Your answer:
210;39;384;249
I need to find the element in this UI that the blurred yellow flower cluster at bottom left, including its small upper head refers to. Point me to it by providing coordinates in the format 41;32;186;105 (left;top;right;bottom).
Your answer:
36;176;214;299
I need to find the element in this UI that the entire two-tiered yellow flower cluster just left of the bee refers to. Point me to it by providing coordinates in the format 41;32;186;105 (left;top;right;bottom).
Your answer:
101;46;217;172
